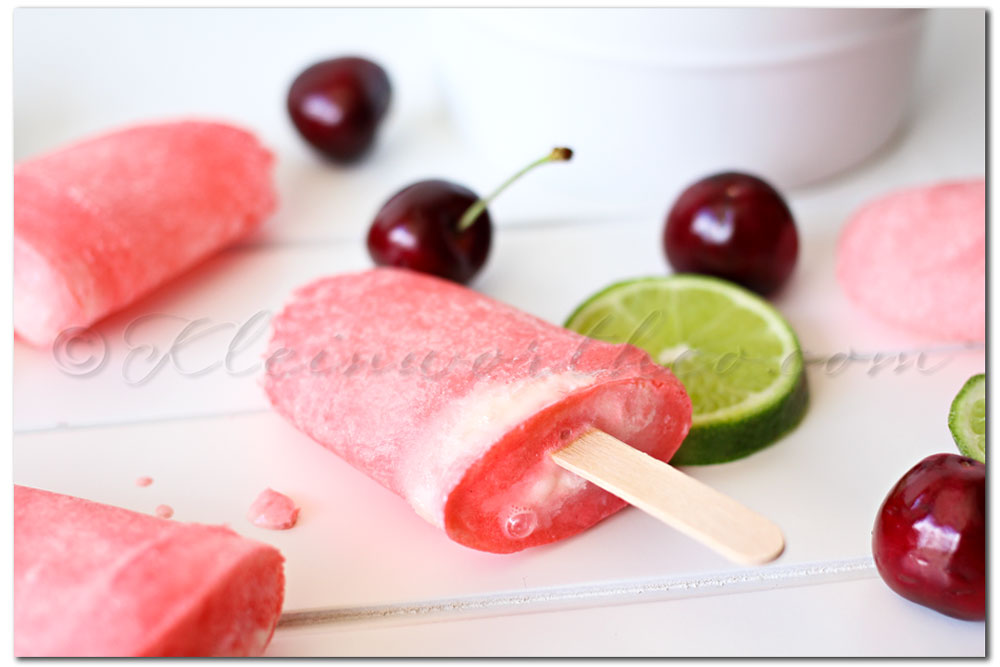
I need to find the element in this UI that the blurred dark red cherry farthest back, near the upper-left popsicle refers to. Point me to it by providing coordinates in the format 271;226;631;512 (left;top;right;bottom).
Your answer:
288;57;391;162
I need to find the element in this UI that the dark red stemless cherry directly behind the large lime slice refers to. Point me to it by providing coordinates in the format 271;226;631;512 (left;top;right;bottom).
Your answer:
663;172;799;295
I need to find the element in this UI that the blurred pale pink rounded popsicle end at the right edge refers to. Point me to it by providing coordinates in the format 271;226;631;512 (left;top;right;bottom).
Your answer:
837;180;986;341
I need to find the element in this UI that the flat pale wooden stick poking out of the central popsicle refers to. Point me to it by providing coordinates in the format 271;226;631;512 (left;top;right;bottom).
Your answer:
550;429;785;565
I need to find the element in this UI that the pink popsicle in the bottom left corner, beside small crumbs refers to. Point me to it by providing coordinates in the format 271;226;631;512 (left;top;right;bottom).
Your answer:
14;486;284;656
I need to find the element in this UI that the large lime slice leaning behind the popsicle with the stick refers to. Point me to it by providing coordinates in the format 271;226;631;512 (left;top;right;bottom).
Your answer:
566;274;809;465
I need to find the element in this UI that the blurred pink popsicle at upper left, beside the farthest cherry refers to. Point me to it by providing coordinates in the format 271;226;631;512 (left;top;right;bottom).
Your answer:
14;121;275;346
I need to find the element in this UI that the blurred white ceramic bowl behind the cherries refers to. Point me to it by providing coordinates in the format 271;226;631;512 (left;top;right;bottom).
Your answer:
432;9;924;203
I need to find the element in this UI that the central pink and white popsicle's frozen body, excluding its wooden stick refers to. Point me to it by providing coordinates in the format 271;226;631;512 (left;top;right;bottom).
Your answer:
264;268;691;553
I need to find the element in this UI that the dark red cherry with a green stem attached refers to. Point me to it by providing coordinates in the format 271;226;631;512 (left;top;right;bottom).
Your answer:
368;148;573;283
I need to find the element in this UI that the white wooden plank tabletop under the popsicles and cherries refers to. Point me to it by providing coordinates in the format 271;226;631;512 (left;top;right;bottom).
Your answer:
13;9;985;656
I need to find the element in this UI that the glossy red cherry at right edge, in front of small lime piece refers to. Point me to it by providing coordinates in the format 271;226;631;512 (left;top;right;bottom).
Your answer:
872;454;986;621
